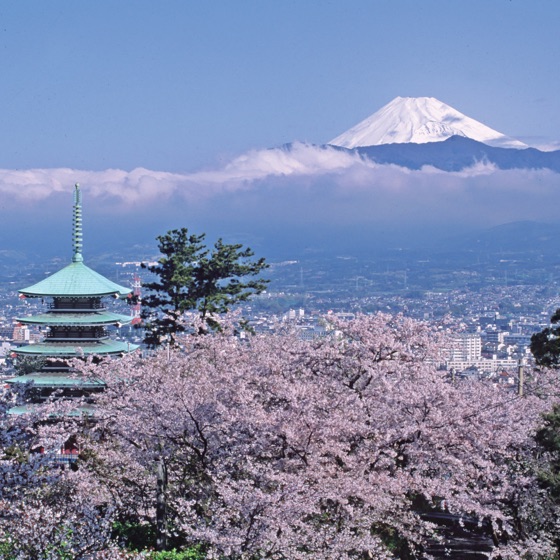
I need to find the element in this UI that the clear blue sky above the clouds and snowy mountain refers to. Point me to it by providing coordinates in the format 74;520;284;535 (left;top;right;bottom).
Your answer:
4;0;560;171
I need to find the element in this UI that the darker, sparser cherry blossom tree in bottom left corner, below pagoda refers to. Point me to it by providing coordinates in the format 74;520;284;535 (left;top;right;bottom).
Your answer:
0;386;127;560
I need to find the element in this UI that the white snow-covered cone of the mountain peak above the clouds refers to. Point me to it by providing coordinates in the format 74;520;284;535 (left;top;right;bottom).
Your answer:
329;97;528;148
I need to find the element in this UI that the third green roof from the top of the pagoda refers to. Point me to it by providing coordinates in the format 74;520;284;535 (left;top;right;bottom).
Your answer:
14;339;138;358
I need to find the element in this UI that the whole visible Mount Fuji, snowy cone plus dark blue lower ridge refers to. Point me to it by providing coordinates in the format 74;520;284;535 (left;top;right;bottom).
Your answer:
327;97;560;173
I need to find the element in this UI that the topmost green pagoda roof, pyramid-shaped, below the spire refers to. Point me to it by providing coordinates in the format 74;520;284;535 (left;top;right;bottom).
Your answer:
19;261;132;297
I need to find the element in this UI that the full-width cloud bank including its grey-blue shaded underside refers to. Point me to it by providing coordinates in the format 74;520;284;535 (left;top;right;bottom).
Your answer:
0;144;560;258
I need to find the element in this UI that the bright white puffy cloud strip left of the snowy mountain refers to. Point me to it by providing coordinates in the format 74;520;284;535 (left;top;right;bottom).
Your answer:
0;144;373;205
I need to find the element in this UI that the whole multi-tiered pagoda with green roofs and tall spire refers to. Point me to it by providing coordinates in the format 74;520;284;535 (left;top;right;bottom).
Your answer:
8;184;138;406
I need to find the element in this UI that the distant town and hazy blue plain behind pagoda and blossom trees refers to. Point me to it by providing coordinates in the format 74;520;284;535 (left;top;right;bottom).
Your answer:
0;243;560;385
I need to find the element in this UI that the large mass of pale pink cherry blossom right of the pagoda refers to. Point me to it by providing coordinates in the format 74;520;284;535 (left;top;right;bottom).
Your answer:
69;314;558;560
